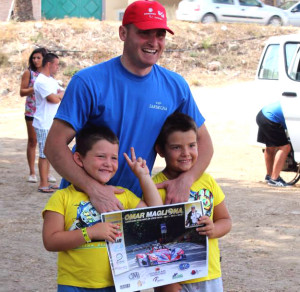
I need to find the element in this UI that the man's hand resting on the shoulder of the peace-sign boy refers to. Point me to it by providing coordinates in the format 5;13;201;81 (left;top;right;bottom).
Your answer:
88;183;124;213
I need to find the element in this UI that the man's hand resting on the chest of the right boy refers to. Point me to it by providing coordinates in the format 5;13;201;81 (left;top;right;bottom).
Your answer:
156;175;193;204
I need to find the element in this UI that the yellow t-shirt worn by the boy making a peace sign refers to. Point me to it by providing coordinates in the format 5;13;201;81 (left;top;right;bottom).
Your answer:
43;185;140;288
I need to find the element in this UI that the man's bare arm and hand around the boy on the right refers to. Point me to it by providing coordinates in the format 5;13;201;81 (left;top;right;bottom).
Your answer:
157;124;213;204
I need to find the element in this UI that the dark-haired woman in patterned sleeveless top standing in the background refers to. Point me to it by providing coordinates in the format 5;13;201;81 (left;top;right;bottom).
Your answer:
20;48;56;183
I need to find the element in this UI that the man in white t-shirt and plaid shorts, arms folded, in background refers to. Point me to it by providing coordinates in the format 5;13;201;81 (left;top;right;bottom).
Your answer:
32;53;64;193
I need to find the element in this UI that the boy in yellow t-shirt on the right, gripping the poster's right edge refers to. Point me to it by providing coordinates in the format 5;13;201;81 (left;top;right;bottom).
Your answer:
153;113;231;292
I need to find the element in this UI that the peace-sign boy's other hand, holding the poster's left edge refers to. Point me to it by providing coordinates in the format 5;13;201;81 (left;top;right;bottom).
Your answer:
87;222;120;242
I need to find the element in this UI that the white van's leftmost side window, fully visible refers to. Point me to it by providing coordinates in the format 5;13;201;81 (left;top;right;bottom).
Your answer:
258;45;279;80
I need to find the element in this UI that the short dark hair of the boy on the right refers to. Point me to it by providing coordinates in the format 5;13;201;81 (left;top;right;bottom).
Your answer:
155;112;197;150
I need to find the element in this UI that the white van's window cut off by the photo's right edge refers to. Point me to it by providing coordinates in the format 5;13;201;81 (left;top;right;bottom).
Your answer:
284;43;300;81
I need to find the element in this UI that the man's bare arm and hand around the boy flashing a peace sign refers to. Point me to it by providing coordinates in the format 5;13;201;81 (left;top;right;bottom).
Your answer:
44;119;123;213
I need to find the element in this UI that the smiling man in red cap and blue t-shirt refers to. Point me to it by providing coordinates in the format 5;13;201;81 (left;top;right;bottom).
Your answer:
46;1;213;212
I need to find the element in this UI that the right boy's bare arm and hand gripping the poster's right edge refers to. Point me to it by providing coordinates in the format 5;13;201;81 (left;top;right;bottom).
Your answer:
196;201;232;238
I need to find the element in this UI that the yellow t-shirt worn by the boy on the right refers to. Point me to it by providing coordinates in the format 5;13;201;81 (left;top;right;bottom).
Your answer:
153;172;225;283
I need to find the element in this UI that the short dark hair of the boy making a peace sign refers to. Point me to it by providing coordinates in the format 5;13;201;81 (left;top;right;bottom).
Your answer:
76;126;119;157
